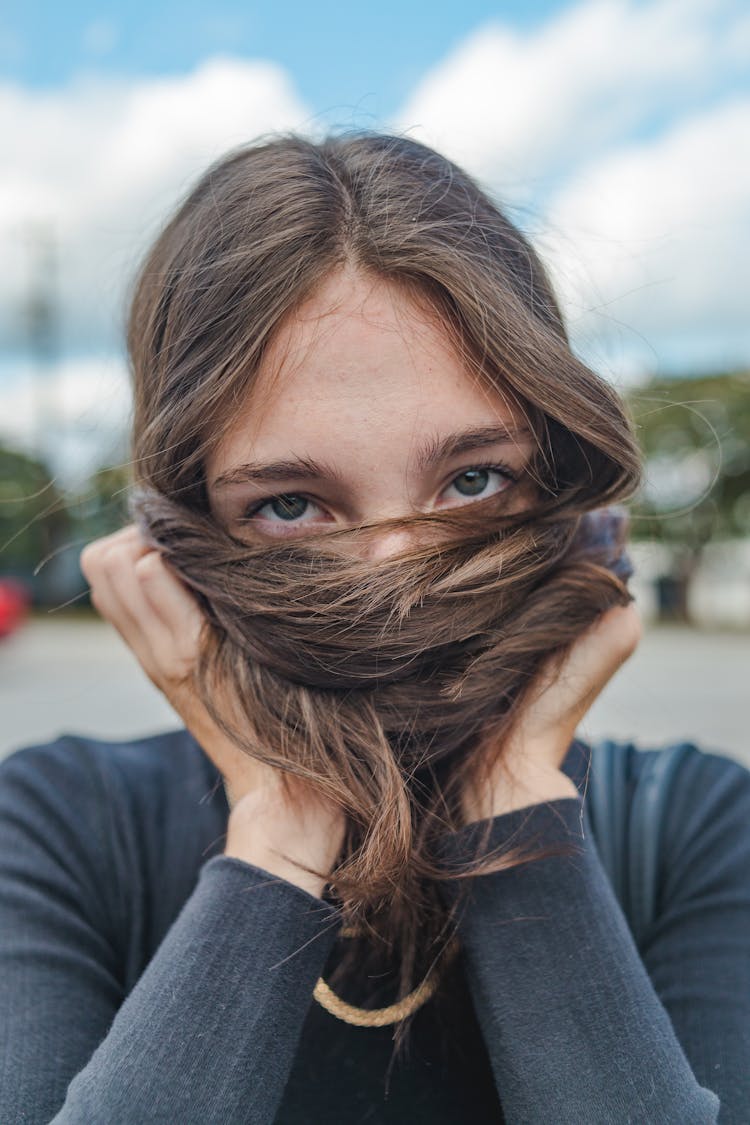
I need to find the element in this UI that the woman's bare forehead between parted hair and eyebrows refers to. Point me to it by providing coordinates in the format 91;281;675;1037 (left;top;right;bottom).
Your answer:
205;270;521;466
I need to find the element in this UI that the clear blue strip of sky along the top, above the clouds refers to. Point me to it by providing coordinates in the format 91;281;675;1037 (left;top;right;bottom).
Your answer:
0;0;566;117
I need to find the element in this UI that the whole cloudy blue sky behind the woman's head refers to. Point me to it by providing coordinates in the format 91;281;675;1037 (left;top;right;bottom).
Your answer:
0;0;750;479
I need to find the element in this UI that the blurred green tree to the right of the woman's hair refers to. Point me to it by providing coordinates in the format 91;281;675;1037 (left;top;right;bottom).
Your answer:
627;371;750;620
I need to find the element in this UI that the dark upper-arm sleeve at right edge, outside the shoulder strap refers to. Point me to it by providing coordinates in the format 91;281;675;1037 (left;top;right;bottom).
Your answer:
643;749;750;1125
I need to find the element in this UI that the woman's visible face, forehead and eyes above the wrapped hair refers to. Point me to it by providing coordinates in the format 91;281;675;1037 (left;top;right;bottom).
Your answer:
206;269;533;558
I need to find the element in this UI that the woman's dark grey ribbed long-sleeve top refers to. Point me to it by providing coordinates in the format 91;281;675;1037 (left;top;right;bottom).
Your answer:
0;731;750;1125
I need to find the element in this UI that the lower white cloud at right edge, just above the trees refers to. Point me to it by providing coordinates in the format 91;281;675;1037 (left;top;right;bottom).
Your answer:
540;98;750;366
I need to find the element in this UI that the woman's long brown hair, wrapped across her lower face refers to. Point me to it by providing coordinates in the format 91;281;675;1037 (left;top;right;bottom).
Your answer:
127;131;641;1050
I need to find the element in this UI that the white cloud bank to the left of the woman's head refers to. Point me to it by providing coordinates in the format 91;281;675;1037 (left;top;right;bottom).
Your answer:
0;57;309;351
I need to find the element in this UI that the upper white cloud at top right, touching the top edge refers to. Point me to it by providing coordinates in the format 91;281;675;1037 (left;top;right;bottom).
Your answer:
395;0;750;199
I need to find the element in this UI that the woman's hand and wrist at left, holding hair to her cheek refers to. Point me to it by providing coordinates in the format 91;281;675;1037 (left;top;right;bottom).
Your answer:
81;524;344;898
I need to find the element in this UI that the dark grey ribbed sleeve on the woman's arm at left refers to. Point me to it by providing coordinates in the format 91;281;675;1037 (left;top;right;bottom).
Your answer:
0;740;336;1125
